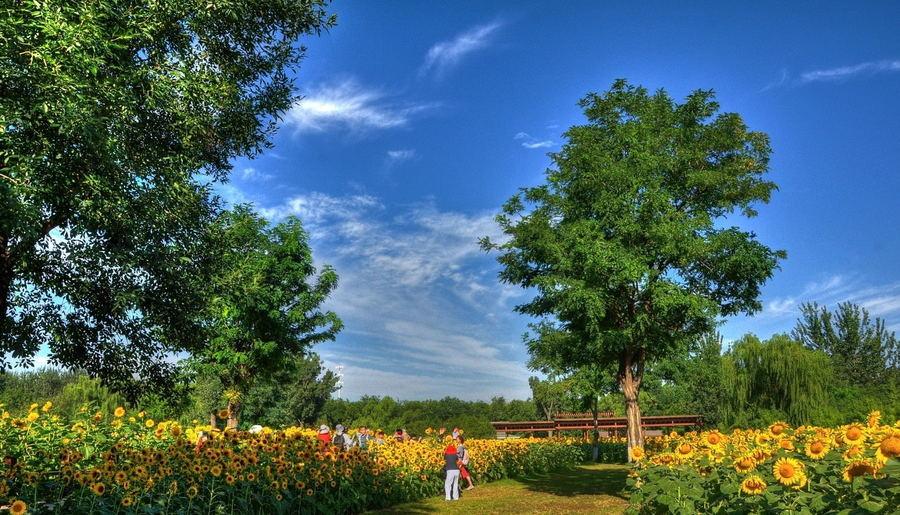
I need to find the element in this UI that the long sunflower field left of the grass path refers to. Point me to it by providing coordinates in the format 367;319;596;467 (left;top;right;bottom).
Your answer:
0;403;584;514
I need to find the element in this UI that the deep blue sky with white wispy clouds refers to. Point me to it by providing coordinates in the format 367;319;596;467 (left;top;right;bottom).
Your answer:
219;1;900;399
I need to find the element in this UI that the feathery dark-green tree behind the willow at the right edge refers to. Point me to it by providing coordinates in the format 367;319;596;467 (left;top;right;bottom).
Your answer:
792;302;900;385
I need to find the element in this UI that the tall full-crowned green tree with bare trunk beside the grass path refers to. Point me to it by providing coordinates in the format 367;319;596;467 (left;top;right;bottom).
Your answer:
482;80;785;456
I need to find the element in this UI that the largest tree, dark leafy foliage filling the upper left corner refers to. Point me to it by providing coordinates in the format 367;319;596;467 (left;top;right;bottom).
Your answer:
0;0;334;394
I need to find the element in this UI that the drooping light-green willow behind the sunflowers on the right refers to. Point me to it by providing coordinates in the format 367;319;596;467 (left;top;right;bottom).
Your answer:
722;335;833;425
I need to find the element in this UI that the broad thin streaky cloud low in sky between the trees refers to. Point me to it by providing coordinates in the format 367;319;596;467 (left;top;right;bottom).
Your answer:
256;193;529;399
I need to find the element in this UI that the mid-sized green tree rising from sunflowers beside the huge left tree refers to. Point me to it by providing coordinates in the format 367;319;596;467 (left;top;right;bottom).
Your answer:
191;206;342;427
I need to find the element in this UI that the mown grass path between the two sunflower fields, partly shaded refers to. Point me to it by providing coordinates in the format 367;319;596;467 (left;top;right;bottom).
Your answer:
377;464;628;515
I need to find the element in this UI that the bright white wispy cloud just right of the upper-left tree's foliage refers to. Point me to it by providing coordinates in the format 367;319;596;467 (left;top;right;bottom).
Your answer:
284;80;437;132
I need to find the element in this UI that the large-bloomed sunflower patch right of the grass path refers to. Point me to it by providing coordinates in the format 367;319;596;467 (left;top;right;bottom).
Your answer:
628;412;900;514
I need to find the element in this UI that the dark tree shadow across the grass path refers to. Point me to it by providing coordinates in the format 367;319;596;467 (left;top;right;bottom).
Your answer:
518;465;628;499
